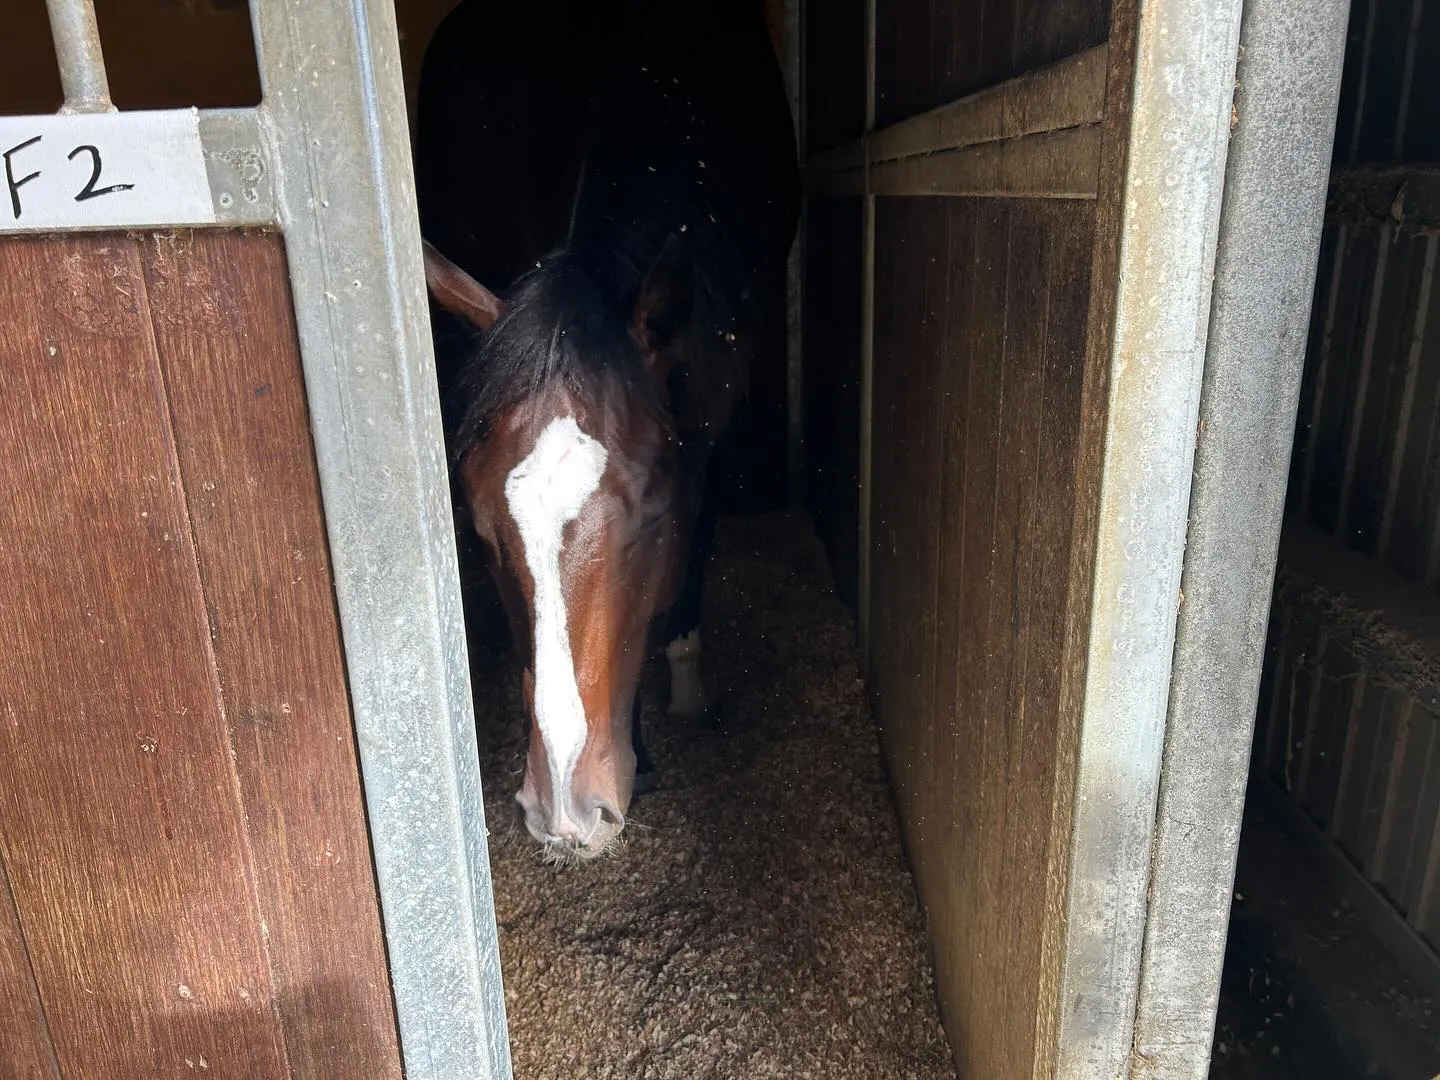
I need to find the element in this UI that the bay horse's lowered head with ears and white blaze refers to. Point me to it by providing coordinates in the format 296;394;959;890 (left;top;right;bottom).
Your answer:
425;238;693;857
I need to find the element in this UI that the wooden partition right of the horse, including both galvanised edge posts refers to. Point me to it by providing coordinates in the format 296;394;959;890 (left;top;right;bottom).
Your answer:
804;0;1345;1080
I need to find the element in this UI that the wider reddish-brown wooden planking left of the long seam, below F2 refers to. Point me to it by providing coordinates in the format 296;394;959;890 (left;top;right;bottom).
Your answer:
0;236;289;1080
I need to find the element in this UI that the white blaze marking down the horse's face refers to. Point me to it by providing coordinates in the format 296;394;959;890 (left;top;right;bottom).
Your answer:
505;416;606;815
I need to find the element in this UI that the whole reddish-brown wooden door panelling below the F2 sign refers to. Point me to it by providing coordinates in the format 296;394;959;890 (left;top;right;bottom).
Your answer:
0;230;400;1080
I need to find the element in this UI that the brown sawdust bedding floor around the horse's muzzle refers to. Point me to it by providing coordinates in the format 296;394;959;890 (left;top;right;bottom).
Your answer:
475;516;955;1080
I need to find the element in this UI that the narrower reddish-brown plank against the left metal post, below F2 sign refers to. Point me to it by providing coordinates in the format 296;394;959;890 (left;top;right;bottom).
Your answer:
145;232;400;1079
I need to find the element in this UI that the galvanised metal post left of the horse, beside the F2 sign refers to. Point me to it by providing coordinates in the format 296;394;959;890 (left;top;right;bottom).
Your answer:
251;0;511;1080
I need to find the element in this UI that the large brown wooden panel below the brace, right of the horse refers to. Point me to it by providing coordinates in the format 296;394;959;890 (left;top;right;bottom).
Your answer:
870;199;1093;1079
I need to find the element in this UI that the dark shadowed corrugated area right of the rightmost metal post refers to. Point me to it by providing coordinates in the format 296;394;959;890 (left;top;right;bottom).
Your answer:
1217;0;1440;1077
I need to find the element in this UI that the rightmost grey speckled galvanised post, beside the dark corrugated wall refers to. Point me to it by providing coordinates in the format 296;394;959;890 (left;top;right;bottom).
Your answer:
1130;0;1349;1080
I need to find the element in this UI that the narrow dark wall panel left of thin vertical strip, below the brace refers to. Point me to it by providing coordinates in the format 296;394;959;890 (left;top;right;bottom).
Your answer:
801;196;864;611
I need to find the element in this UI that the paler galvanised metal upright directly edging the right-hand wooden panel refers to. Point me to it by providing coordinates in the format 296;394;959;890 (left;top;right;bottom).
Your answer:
1053;0;1249;1080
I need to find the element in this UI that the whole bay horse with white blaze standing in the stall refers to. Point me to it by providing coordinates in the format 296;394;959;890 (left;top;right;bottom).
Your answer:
416;0;799;858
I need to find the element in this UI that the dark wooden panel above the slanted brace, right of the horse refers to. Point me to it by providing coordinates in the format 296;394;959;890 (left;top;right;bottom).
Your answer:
869;0;1110;128
